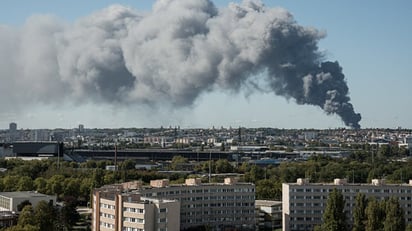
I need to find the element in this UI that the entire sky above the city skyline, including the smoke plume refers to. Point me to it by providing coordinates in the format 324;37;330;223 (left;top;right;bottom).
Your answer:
0;0;412;129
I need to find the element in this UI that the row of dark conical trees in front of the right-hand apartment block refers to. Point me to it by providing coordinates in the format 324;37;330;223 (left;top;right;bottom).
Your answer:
315;188;412;231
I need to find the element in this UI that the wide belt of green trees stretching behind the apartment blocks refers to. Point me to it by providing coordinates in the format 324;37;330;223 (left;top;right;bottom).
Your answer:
0;153;412;202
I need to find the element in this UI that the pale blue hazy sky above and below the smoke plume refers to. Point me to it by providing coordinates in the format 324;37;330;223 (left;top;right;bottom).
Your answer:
0;0;412;129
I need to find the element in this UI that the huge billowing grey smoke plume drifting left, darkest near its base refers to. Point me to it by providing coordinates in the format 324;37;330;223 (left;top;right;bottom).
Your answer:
0;0;361;128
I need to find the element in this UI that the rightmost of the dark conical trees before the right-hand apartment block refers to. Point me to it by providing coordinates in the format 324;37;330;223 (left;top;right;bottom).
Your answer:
383;197;406;231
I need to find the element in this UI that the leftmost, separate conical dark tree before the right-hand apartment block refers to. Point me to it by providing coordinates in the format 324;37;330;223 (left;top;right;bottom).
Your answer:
321;188;347;231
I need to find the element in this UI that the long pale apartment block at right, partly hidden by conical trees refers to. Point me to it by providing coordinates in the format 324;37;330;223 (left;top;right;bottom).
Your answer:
282;178;412;231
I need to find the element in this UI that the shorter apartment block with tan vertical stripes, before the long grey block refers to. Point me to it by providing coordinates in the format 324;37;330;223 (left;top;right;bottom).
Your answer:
92;187;180;231
